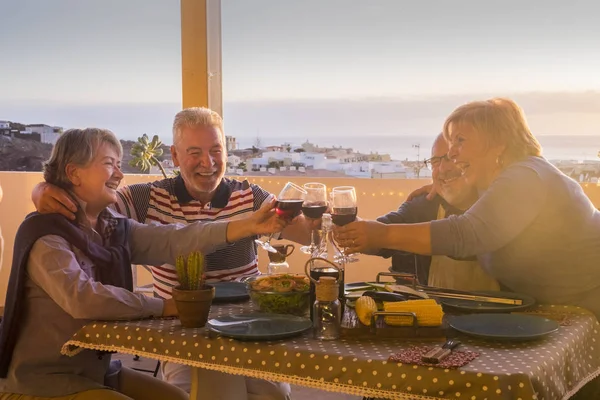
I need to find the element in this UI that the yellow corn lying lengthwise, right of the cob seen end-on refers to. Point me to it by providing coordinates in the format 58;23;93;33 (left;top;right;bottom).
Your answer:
383;299;444;326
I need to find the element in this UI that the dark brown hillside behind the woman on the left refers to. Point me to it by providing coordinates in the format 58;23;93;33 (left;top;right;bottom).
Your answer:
0;136;171;174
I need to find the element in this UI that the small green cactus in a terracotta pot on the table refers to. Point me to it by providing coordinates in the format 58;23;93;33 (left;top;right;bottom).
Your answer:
173;252;215;328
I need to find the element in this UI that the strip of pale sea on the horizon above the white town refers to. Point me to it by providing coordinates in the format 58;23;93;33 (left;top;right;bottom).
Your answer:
237;134;600;161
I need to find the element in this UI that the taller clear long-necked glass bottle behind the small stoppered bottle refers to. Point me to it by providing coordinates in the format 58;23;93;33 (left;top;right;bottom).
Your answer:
310;213;344;321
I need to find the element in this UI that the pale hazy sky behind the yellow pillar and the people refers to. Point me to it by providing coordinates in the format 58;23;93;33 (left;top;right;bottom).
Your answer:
0;0;600;147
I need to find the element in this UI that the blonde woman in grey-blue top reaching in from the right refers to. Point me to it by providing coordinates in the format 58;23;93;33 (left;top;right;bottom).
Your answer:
337;98;600;318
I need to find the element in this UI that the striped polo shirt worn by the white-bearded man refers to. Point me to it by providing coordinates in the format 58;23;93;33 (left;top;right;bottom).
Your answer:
115;176;271;298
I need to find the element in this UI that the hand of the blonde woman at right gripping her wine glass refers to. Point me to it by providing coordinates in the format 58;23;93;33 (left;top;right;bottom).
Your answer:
333;221;387;254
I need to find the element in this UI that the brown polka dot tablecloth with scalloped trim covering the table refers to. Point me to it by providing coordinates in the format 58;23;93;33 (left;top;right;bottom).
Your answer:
63;303;600;400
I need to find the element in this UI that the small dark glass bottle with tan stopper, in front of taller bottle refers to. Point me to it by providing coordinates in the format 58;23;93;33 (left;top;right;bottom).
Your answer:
312;276;342;340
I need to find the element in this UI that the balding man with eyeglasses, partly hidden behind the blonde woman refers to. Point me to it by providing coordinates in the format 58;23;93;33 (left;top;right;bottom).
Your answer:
377;134;499;290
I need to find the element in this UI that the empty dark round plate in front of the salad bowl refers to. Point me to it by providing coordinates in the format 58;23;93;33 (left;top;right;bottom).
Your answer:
206;313;312;340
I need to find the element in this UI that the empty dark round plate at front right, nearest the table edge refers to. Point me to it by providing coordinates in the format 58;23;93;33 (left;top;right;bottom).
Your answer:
447;314;559;341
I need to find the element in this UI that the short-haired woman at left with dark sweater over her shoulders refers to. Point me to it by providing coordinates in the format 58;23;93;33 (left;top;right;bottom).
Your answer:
0;128;285;400
